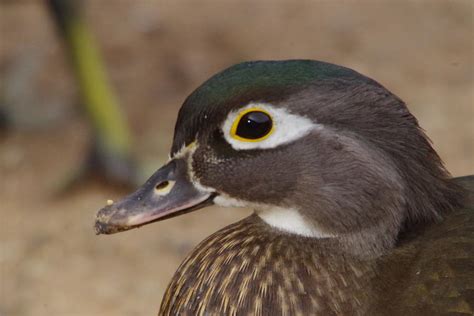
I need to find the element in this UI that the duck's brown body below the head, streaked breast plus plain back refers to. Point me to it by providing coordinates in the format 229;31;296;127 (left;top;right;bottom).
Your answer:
159;184;474;315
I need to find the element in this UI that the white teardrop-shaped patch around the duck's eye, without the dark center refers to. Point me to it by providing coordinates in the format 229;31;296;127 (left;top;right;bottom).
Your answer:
222;103;322;150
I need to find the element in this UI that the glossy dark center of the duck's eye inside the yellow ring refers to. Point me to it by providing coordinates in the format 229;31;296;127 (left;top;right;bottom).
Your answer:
236;111;272;139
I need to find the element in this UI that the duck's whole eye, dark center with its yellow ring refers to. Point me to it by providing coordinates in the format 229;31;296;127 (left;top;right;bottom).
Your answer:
230;107;275;142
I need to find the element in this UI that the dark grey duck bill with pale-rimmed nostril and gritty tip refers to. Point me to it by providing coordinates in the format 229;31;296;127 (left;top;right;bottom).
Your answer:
95;159;214;234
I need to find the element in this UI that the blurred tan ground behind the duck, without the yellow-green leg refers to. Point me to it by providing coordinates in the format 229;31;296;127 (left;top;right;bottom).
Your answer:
0;0;474;316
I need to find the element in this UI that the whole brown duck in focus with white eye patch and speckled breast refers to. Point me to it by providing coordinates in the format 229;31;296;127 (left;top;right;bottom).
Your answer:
95;60;474;315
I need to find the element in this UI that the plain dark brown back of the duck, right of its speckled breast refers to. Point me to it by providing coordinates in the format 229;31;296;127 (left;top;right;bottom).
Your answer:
373;195;474;316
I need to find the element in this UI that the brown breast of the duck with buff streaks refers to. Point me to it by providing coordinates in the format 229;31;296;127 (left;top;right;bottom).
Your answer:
160;215;374;315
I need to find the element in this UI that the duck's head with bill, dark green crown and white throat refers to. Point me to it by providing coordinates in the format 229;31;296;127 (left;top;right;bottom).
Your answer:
96;60;459;254
